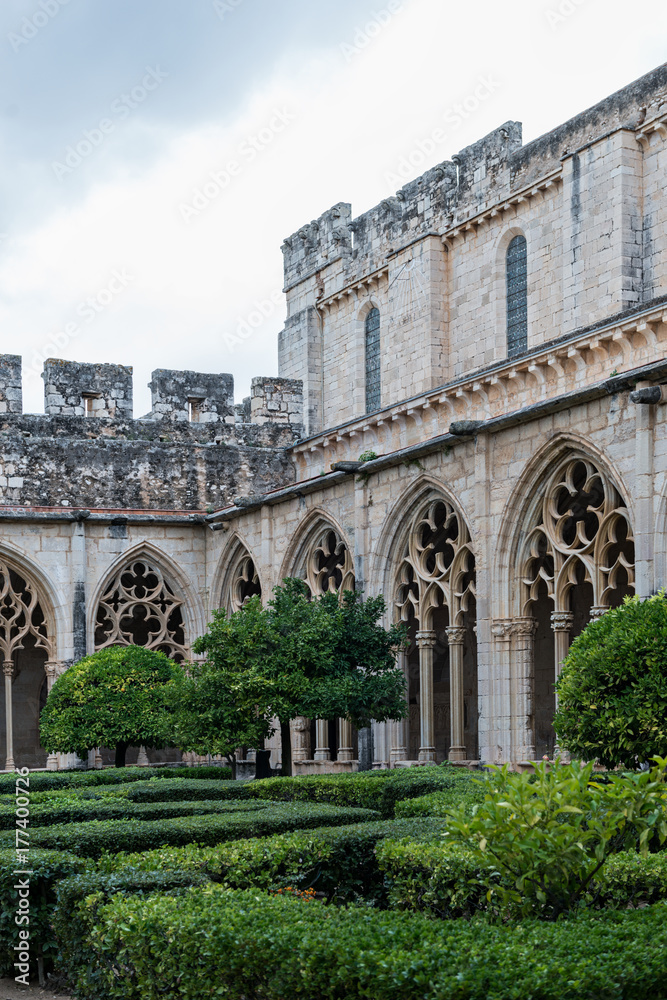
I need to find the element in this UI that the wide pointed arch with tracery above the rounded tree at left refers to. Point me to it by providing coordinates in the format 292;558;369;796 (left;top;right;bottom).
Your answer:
88;542;206;659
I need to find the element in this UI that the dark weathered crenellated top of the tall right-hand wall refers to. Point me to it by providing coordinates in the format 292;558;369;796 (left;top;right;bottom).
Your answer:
282;63;667;290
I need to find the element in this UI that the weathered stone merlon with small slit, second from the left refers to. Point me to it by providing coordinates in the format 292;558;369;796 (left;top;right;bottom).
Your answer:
43;358;132;420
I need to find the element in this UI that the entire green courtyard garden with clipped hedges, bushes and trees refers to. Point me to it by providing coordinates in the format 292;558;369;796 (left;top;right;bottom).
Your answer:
0;592;667;1000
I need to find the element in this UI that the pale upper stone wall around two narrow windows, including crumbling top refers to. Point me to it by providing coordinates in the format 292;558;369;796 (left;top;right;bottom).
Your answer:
279;64;667;435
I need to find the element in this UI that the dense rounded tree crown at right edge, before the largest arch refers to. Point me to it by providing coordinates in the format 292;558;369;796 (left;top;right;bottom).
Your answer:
554;593;667;768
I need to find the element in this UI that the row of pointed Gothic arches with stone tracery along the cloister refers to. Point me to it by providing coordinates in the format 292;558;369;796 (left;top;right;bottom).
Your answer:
0;447;634;770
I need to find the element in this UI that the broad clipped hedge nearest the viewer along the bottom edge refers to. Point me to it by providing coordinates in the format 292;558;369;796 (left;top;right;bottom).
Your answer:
77;885;667;1000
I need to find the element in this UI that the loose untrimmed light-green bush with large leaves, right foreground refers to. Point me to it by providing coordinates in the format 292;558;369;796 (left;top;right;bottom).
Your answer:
445;759;667;919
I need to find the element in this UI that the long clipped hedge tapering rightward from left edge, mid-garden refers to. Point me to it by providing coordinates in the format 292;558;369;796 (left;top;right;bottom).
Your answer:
0;802;378;857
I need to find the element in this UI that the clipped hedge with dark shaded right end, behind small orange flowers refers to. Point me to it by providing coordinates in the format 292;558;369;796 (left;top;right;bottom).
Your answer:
99;820;442;902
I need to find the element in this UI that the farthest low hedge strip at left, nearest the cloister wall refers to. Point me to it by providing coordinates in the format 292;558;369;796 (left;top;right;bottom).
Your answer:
0;765;232;794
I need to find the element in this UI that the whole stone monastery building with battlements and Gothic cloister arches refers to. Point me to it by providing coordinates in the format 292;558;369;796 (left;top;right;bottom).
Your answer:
0;64;667;771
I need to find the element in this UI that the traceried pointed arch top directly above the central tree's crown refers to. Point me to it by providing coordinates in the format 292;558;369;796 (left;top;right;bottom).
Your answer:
280;508;354;594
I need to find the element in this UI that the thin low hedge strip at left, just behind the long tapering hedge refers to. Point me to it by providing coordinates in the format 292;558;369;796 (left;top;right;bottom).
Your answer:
0;796;269;830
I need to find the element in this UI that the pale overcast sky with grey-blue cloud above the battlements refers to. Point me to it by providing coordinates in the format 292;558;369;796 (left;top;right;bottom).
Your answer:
0;0;667;415
